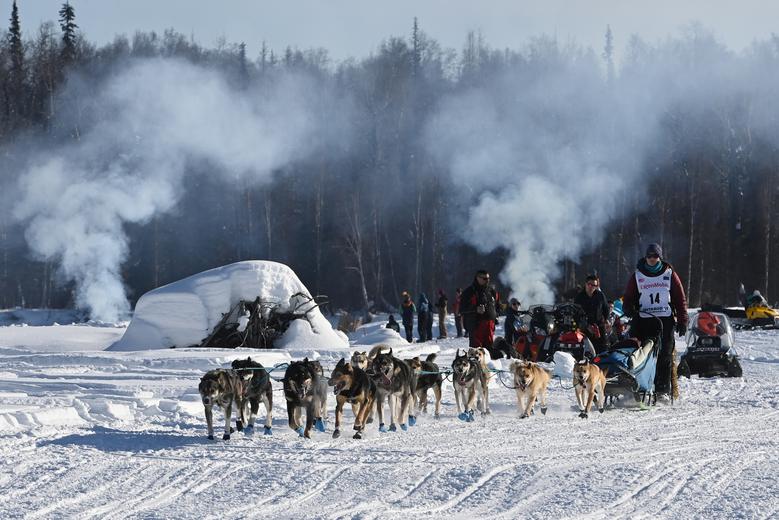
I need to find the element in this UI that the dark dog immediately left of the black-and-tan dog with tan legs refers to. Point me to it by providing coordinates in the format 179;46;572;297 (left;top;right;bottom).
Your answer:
282;358;327;439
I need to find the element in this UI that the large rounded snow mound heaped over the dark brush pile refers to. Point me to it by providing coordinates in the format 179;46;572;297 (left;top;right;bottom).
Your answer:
108;260;348;350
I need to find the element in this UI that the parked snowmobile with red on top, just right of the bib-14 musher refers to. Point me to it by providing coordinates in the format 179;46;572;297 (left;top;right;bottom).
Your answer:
677;311;742;378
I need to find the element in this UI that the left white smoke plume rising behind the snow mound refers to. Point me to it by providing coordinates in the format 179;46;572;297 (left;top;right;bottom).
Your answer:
14;59;348;321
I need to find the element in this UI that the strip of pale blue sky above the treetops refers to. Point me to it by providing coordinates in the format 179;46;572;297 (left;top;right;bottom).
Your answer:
0;0;779;59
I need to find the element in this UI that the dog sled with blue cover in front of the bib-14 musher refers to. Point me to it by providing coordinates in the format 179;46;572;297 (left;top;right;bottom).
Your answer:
592;338;660;405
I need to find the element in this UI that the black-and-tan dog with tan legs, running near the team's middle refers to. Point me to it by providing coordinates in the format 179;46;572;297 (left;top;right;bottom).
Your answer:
327;358;376;439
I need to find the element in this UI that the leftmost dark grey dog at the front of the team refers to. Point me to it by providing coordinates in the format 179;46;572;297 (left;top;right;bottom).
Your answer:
197;368;252;441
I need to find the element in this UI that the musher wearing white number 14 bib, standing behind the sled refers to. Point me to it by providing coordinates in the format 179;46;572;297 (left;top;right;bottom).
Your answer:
623;244;687;396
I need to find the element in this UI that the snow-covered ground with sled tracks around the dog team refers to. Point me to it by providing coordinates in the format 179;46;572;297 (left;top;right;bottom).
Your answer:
0;312;779;519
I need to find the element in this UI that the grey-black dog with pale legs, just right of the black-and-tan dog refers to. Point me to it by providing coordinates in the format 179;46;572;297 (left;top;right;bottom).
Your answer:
370;345;412;431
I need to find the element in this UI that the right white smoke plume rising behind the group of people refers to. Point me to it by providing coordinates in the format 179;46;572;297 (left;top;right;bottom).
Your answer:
425;32;779;303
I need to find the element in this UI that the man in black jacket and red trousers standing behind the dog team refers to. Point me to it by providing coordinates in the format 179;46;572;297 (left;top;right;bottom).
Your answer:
460;270;500;349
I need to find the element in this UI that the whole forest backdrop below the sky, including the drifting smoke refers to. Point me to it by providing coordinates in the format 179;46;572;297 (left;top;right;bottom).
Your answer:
0;3;779;319
